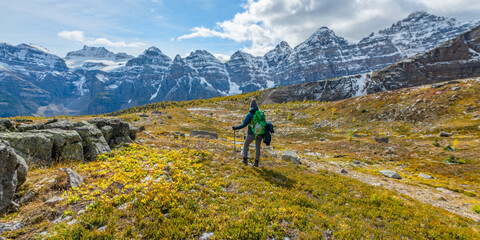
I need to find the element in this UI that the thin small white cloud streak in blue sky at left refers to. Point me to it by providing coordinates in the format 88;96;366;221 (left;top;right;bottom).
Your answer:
57;31;146;48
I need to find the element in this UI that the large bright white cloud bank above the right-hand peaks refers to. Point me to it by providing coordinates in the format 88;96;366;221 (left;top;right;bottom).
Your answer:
178;0;480;55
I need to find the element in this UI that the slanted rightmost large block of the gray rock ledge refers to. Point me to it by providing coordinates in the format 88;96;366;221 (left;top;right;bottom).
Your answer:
75;122;110;160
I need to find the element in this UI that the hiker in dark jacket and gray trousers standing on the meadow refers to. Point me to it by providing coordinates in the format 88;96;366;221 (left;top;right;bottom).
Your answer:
232;99;265;167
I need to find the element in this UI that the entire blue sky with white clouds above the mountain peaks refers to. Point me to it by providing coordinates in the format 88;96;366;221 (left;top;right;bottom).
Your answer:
0;0;480;58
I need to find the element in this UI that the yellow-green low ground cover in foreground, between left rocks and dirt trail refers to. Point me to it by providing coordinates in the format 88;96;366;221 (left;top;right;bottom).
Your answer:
43;145;480;239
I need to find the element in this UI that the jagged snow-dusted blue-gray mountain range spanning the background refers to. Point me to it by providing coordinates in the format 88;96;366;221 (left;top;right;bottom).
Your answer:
0;12;480;117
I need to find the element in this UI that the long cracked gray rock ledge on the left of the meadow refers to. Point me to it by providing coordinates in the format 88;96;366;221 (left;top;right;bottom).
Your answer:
0;118;138;163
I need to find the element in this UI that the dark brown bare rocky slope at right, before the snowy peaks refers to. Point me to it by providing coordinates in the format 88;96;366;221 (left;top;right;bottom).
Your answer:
263;26;480;103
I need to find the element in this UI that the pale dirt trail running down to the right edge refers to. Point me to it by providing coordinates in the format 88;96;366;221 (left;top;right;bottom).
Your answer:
302;159;480;222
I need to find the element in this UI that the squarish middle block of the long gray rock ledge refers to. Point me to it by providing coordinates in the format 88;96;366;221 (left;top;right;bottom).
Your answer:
30;129;83;161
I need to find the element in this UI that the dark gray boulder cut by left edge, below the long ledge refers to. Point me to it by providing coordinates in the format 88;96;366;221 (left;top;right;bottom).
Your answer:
0;140;24;214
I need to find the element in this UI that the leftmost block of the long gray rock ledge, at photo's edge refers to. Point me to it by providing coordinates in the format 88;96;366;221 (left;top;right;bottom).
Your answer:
0;132;53;163
